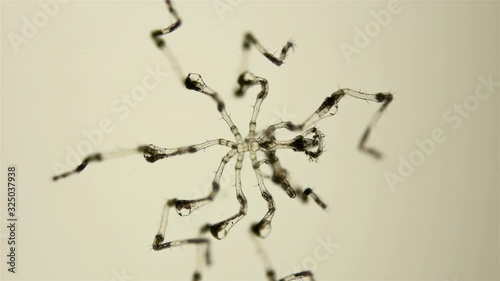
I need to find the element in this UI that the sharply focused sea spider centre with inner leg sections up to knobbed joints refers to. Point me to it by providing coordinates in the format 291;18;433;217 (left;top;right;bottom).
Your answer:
142;72;326;241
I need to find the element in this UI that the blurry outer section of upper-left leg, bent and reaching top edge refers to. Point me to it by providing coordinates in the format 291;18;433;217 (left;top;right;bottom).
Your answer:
151;0;185;82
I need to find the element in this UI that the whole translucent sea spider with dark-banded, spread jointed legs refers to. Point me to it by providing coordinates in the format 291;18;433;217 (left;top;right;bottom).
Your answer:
53;0;392;281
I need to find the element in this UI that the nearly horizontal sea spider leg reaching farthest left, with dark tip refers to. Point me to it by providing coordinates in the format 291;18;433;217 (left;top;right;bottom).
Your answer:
52;139;236;181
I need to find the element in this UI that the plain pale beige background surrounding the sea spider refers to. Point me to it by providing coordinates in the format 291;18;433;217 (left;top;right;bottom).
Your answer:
1;0;500;281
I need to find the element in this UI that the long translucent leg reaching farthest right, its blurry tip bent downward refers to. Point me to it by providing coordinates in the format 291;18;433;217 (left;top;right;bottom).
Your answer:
261;89;393;159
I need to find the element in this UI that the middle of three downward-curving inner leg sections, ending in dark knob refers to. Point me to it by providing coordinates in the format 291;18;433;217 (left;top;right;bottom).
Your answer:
210;153;248;240
